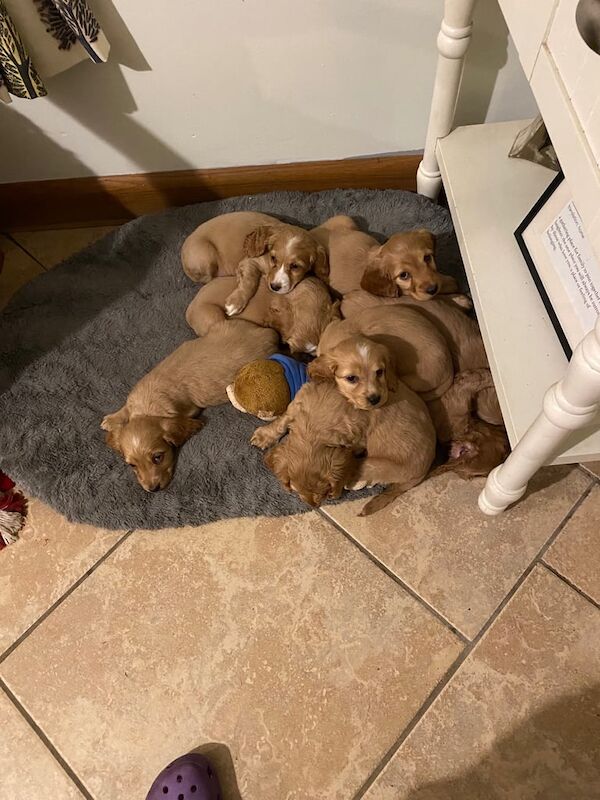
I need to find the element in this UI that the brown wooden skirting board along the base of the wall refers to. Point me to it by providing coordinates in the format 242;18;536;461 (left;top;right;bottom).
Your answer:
0;154;421;232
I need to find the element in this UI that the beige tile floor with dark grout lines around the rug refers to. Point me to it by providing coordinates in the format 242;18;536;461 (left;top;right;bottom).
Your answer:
0;229;600;800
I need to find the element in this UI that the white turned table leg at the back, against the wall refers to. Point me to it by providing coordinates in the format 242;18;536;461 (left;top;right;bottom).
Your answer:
417;0;476;200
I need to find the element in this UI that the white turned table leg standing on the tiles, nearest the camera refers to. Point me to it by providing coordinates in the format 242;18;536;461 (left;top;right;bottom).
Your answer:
479;317;600;514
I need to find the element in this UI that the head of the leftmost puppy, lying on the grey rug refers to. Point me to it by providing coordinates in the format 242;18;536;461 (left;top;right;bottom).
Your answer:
102;408;202;492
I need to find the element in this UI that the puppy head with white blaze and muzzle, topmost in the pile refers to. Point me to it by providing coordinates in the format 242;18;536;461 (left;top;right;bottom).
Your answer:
244;224;329;294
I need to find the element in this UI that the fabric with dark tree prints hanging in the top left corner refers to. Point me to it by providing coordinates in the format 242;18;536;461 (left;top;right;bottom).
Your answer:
0;0;110;102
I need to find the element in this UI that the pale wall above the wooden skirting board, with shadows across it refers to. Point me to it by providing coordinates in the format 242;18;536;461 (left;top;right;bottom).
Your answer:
0;0;535;182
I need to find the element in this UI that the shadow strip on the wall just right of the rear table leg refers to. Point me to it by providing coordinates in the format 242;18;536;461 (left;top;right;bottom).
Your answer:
455;0;508;127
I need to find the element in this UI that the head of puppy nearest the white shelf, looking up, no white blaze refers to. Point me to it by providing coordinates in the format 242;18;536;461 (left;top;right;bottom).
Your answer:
361;230;440;300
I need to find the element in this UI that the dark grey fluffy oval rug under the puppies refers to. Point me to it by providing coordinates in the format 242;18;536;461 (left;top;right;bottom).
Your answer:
0;190;464;529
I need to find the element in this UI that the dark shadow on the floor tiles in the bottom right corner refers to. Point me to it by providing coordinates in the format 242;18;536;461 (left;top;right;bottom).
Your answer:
394;684;600;800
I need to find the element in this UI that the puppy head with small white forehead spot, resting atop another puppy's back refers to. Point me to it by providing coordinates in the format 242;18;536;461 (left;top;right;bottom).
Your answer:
308;336;396;410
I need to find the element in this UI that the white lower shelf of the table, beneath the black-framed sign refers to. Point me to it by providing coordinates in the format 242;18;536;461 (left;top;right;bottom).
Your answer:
436;120;600;464
